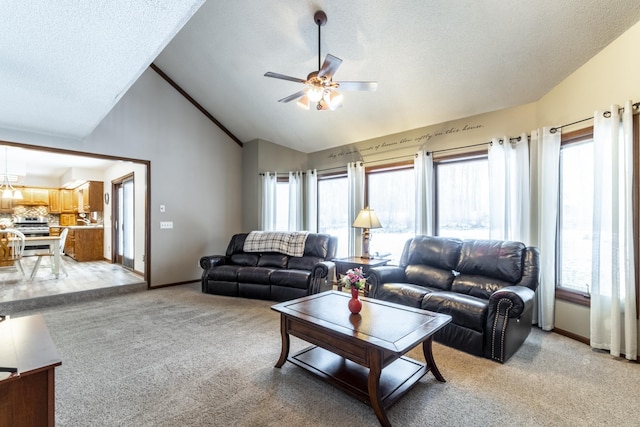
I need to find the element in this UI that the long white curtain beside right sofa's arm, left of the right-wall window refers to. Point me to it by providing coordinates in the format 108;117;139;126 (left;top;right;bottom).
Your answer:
531;127;560;331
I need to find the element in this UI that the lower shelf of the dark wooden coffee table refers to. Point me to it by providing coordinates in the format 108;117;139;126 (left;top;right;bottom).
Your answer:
287;346;430;409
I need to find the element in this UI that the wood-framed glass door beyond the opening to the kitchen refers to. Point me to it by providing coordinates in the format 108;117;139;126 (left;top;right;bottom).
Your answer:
111;173;135;270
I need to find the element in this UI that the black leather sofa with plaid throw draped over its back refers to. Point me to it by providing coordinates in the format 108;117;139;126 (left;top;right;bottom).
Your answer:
200;233;338;301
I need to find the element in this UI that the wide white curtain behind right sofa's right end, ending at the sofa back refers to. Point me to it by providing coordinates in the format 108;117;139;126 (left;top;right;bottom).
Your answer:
488;133;531;245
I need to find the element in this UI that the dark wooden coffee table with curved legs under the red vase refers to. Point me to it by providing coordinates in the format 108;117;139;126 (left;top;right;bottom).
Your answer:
271;291;451;426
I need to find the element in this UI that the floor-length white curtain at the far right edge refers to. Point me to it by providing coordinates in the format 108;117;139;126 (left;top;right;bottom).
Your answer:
590;101;638;360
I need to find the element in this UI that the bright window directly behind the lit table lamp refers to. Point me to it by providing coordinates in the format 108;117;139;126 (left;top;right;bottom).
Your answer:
366;163;416;261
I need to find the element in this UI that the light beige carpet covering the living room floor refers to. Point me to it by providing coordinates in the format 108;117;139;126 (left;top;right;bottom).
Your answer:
13;284;640;427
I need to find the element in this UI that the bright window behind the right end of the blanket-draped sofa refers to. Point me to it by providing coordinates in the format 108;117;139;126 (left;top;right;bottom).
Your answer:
318;174;351;258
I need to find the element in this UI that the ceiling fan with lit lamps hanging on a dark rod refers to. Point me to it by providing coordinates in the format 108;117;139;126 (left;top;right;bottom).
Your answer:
264;10;378;110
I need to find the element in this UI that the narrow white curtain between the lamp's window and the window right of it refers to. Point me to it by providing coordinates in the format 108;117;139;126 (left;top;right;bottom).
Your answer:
413;151;434;236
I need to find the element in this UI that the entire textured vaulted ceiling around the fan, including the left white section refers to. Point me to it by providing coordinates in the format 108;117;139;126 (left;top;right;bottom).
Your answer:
0;0;640;152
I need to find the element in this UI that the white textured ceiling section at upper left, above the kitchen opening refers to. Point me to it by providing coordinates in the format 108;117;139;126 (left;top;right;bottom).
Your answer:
0;0;204;138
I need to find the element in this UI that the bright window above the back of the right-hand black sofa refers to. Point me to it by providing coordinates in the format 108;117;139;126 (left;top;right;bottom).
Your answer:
434;156;490;239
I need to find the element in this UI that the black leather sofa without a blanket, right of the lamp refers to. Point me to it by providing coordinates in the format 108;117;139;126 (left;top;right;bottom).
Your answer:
368;236;540;363
